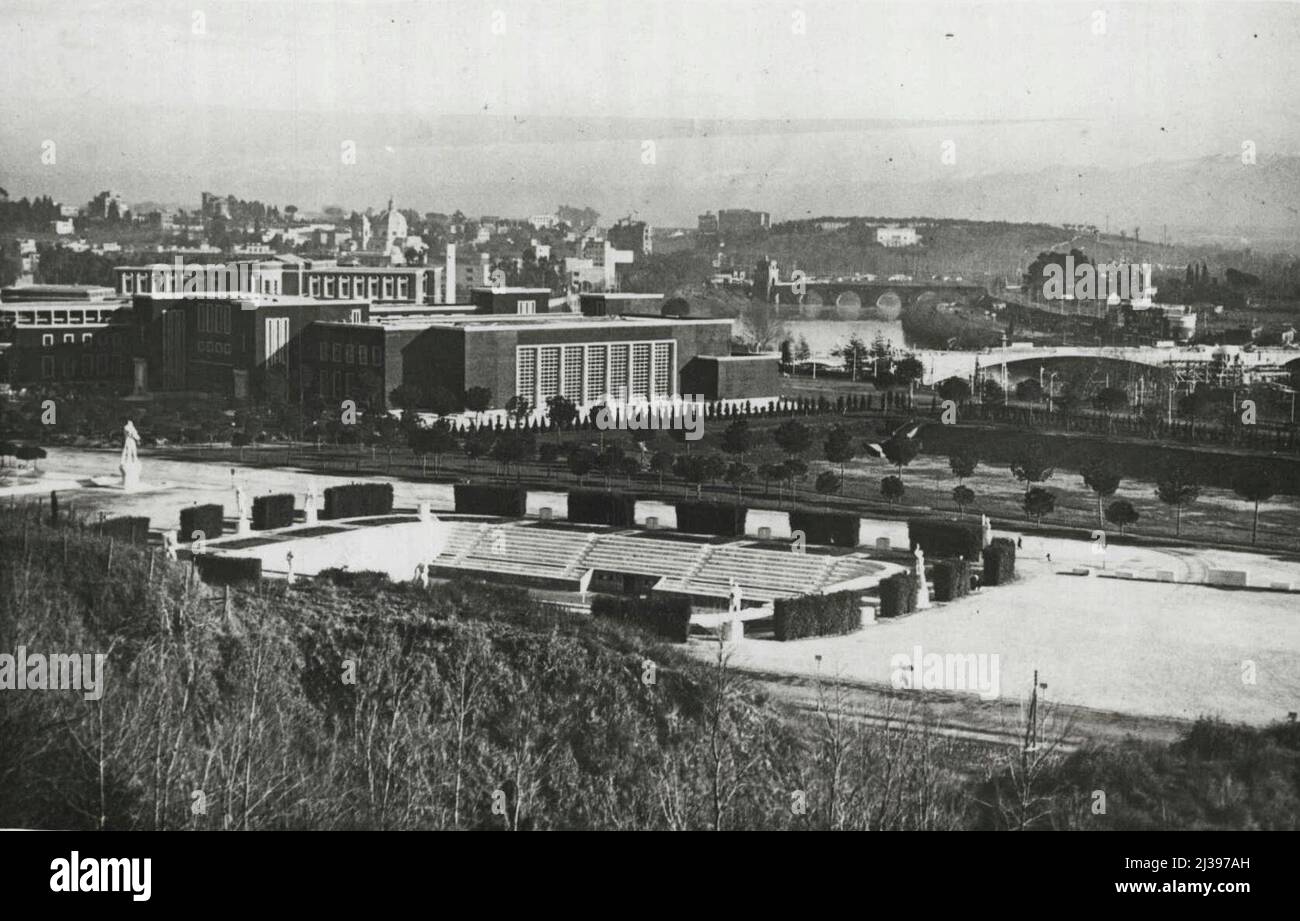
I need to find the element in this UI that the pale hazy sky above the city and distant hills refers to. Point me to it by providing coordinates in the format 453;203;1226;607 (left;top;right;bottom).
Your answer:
0;0;1300;221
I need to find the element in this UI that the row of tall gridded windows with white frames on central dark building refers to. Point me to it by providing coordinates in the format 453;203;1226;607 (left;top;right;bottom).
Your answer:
515;340;677;406
